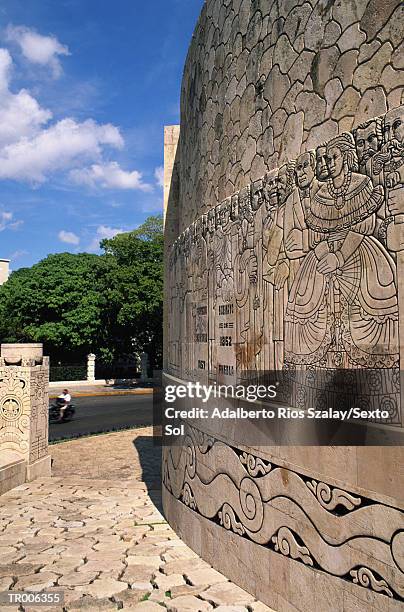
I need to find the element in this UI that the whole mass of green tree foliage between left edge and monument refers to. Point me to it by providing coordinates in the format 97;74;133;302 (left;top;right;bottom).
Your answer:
0;217;163;366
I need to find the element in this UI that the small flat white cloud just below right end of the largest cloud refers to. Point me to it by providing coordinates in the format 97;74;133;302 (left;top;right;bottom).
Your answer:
70;162;153;191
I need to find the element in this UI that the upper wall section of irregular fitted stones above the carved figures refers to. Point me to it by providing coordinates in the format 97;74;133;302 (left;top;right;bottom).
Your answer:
179;0;404;231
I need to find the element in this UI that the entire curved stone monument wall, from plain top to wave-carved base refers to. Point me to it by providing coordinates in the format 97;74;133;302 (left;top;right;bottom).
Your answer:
163;0;404;612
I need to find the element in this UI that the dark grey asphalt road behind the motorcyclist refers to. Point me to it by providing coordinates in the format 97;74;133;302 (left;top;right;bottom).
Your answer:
49;395;153;441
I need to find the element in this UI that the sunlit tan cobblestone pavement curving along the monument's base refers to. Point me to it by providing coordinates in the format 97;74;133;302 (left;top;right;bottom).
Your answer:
0;428;269;612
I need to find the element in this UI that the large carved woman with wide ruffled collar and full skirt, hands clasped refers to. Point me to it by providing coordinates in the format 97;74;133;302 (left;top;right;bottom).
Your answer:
285;134;398;368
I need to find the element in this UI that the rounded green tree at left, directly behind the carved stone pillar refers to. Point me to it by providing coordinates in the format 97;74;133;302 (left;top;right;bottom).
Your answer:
0;253;108;359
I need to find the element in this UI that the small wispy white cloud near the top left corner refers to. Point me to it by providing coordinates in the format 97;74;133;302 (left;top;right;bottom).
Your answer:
6;25;70;78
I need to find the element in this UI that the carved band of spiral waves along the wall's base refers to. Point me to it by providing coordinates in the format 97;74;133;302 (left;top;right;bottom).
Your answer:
163;426;404;601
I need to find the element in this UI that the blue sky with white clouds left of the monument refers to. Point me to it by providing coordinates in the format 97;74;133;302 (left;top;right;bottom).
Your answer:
0;0;203;270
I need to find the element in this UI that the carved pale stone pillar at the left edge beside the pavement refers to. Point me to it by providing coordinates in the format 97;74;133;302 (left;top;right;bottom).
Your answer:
0;344;51;493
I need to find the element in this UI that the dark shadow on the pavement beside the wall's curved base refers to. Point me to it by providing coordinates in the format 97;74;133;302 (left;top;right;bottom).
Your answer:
133;436;163;513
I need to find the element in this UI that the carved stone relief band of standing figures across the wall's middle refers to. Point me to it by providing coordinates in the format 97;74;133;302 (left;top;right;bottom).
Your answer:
167;106;404;425
